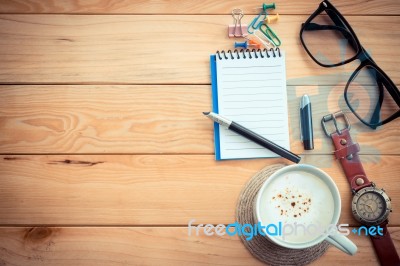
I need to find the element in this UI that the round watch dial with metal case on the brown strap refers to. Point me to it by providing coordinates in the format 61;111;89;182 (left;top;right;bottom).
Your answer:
352;187;390;225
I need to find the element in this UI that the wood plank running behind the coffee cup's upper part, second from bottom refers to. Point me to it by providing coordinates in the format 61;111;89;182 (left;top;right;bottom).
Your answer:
0;155;400;226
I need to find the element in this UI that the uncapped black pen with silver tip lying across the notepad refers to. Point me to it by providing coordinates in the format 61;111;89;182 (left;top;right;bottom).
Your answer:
203;112;301;163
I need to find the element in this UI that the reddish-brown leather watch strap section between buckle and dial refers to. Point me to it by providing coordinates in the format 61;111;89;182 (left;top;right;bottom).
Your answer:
331;128;372;191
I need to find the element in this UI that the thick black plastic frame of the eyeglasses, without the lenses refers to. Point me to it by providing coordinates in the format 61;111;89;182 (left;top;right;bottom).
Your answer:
300;1;400;129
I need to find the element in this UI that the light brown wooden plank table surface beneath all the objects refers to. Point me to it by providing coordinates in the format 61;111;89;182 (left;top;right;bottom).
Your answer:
0;0;400;265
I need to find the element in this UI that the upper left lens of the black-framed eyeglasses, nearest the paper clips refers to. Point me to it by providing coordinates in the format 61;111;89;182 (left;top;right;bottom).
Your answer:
301;9;360;66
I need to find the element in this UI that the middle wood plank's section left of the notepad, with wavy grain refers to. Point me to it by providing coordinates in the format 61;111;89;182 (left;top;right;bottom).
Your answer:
0;86;213;153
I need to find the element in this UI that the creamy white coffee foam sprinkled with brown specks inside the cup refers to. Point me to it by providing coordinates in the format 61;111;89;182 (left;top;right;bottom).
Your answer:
260;171;335;243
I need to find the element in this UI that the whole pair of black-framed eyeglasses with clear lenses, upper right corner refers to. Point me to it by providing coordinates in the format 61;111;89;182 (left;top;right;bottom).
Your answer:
300;1;400;129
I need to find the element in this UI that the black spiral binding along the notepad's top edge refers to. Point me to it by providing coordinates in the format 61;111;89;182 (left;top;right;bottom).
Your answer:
216;48;282;60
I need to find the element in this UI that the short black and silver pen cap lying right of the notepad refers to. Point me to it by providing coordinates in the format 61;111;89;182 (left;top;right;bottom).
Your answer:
300;94;314;150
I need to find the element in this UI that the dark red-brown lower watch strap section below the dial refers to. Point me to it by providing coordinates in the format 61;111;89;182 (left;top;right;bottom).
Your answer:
371;221;400;266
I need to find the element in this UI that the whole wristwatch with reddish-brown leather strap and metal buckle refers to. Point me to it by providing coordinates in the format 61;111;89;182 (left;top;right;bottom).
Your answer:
322;112;400;266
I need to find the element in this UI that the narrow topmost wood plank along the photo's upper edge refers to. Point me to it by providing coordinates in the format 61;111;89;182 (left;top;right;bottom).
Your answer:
0;0;400;15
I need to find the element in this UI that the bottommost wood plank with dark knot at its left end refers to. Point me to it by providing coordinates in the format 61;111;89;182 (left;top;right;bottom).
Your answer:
0;227;400;266
